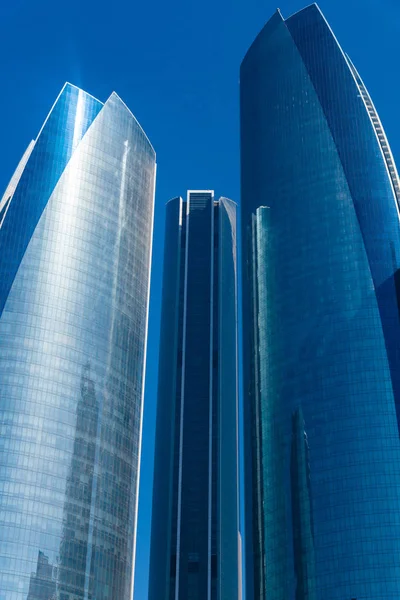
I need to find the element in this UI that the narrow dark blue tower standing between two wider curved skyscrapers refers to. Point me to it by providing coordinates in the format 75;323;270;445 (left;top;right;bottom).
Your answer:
149;191;239;600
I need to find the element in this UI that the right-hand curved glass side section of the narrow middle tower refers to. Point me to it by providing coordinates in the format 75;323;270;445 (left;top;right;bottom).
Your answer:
214;198;239;600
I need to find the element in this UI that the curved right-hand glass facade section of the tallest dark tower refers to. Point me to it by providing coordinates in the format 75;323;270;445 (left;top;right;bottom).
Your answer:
286;5;400;436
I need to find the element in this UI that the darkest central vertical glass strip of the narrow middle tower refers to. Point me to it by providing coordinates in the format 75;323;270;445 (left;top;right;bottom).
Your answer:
179;192;213;600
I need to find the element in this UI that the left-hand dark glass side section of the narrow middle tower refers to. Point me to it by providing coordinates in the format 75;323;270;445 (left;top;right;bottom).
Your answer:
149;198;186;600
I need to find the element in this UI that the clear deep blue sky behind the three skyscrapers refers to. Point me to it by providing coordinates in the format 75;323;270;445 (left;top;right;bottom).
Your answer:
0;0;400;600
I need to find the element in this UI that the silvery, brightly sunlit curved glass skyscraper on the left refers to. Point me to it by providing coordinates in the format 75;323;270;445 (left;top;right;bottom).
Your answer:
0;84;155;600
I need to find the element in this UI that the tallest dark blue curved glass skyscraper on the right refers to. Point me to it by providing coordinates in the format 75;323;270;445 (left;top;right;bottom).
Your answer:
240;4;400;600
